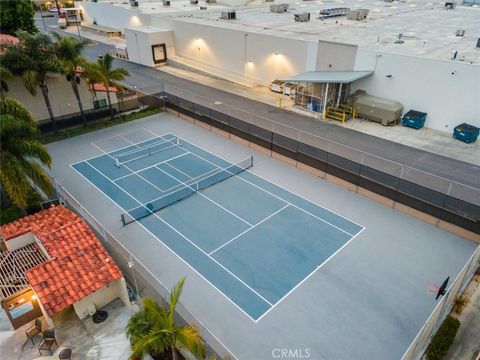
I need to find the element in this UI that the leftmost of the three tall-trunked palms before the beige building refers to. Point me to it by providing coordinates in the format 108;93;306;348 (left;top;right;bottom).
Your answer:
2;31;63;133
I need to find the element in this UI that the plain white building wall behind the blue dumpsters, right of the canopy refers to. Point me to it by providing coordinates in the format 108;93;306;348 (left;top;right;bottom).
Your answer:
352;49;480;133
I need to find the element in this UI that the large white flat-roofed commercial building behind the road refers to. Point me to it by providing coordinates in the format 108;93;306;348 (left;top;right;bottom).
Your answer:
76;0;480;133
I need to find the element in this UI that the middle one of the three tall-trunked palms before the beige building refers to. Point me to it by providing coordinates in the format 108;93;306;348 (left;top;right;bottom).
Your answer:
53;32;90;126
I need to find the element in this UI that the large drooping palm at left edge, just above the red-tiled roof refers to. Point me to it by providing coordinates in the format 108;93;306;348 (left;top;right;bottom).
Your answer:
0;97;52;208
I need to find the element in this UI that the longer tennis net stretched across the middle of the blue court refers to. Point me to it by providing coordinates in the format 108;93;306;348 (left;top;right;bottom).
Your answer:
120;156;253;226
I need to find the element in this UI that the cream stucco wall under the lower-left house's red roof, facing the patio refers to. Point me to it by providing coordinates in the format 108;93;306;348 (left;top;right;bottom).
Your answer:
73;277;130;319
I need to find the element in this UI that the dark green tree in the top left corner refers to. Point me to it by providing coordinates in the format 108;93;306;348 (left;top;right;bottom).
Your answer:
0;0;38;35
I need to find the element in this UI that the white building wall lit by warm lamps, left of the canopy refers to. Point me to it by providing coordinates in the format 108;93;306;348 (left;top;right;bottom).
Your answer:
159;20;317;85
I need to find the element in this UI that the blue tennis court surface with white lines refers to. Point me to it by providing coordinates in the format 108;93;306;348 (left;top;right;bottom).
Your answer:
71;134;363;321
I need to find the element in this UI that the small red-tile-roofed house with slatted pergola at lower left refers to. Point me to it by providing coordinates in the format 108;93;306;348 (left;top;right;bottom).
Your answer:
0;205;130;328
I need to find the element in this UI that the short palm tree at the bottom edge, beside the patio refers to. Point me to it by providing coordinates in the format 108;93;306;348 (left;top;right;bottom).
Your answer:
127;278;205;360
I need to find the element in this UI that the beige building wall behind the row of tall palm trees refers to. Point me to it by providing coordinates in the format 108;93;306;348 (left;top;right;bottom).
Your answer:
7;75;117;121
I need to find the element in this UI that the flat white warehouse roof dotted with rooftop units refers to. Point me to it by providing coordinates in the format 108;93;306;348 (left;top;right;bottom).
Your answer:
176;0;480;63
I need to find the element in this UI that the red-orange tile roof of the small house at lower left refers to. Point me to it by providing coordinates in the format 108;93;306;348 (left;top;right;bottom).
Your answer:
0;206;123;316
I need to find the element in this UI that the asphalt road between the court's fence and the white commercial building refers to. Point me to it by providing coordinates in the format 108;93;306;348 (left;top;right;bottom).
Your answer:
39;18;480;194
